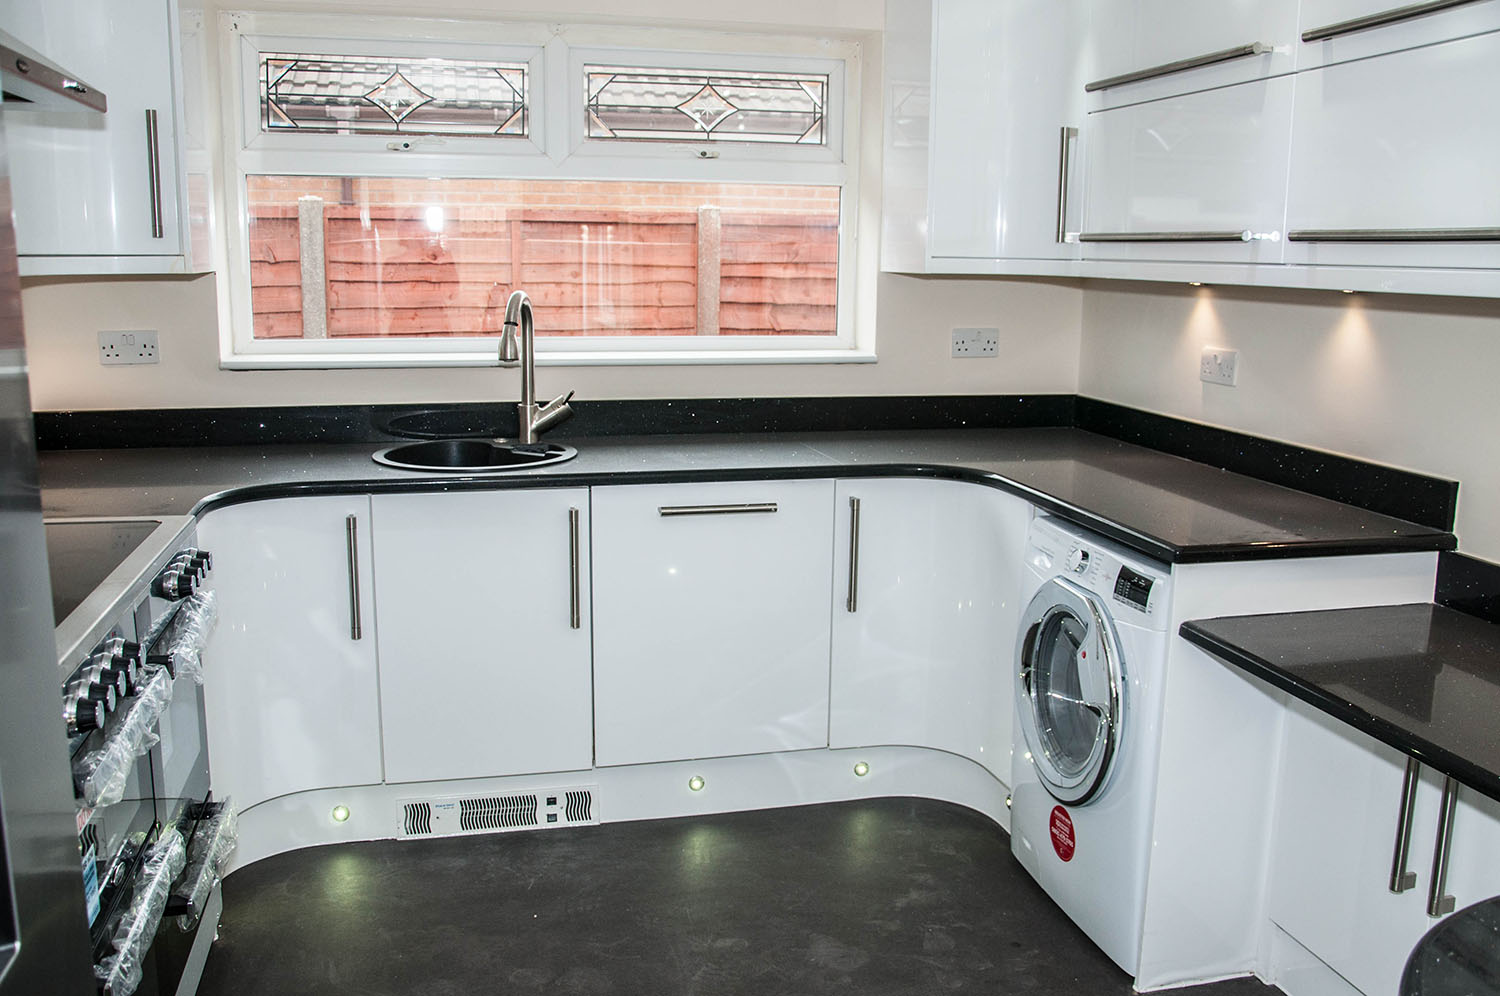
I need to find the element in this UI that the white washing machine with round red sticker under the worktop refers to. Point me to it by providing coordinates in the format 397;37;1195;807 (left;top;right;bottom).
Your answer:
1011;518;1172;977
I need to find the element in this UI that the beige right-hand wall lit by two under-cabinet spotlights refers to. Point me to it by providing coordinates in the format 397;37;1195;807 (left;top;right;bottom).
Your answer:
1079;281;1500;561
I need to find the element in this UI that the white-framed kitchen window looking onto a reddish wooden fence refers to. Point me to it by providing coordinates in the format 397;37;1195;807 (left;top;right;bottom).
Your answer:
222;14;873;368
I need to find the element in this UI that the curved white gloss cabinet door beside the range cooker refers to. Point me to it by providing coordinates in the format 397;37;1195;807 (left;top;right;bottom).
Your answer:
198;495;381;810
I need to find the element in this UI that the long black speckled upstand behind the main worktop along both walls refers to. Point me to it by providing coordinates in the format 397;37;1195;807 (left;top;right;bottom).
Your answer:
35;395;1458;533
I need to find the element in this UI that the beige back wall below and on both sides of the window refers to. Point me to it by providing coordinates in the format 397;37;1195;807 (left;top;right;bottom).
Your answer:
21;275;1083;411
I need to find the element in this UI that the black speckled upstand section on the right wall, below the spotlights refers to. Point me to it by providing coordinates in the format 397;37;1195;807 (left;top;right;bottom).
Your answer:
1074;396;1458;531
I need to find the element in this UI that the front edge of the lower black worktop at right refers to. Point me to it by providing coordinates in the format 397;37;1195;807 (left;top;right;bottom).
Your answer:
1178;615;1500;801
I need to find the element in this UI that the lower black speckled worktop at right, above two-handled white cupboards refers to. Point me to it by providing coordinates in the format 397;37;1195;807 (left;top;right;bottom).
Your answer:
1181;603;1500;800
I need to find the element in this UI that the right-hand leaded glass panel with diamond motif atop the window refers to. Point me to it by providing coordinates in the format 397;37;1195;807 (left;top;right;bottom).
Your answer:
584;66;828;146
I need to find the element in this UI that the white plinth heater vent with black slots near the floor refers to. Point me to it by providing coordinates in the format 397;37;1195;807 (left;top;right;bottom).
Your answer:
396;786;599;837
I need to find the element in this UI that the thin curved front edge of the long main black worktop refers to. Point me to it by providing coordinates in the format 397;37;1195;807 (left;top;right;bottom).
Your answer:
181;464;1457;564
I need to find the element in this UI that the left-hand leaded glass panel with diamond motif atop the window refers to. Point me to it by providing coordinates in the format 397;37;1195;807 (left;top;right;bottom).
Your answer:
261;53;528;137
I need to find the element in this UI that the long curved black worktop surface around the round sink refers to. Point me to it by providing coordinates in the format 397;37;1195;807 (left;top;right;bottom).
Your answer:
41;428;1455;563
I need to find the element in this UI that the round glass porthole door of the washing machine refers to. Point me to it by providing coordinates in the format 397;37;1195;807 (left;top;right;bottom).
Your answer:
1016;578;1125;806
